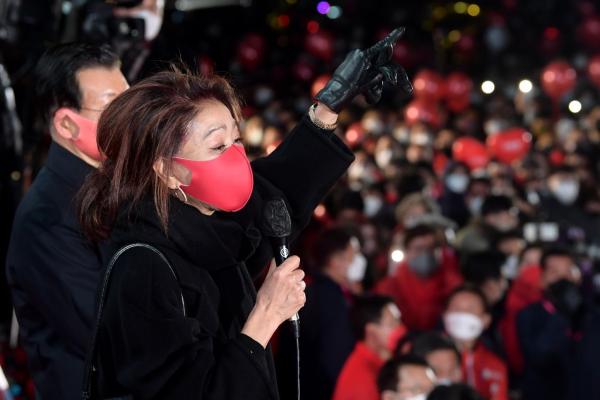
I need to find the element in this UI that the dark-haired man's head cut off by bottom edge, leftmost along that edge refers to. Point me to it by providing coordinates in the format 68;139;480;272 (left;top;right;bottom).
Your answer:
377;354;436;400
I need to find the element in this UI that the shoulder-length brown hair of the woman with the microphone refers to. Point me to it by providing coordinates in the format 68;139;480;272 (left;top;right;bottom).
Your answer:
78;67;241;240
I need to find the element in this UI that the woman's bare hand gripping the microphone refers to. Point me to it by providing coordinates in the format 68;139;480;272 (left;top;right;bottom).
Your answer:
242;256;306;347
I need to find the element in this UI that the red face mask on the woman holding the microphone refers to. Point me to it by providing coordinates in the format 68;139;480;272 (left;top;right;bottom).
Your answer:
173;144;254;212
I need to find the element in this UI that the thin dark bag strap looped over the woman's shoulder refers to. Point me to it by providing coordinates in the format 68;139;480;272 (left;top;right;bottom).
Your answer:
82;243;187;400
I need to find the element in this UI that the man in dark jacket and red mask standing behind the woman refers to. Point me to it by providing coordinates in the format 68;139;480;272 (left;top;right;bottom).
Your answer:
6;43;128;399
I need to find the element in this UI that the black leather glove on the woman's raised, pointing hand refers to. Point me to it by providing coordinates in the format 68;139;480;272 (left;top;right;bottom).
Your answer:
315;28;412;113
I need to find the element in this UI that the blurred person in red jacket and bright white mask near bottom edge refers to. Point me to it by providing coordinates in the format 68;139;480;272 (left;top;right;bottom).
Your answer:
444;285;508;400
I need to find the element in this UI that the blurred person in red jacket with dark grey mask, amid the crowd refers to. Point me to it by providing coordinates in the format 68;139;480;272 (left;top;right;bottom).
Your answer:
375;225;462;331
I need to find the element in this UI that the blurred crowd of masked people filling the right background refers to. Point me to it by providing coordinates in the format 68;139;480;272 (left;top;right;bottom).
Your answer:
244;60;600;400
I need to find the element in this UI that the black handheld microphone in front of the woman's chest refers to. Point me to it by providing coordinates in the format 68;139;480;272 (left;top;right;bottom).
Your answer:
262;199;300;338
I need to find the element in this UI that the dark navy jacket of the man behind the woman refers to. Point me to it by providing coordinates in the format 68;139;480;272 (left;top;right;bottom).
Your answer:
6;143;102;400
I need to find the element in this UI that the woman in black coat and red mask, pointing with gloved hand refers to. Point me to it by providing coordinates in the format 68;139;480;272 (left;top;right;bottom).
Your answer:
79;26;411;399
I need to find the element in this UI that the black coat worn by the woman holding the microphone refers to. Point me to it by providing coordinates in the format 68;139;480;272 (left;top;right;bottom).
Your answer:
98;117;353;400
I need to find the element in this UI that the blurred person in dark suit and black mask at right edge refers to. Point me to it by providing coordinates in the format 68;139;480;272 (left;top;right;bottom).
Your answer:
517;247;600;400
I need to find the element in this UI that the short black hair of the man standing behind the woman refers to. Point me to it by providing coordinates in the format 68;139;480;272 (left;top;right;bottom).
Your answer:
34;43;120;126
